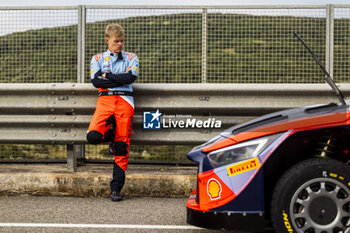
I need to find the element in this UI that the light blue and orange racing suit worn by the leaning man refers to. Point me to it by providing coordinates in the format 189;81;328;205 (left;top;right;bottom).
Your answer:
87;50;139;192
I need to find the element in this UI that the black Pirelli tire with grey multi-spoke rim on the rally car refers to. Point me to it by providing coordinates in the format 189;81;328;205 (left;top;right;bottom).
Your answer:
271;158;350;233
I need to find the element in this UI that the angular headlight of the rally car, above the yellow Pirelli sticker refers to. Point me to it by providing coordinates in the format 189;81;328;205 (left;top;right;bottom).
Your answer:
208;134;281;167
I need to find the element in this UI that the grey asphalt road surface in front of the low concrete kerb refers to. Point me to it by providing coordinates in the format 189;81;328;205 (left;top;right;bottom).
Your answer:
0;196;227;233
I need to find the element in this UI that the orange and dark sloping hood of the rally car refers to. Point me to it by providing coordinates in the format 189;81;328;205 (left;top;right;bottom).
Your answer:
192;103;349;152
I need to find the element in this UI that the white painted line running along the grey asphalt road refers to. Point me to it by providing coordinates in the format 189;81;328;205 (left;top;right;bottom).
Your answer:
0;223;203;230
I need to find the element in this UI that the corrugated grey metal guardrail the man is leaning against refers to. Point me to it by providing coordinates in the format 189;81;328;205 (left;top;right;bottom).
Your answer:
0;83;350;171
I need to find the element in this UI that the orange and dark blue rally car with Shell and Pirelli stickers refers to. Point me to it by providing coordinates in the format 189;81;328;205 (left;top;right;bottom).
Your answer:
186;34;350;233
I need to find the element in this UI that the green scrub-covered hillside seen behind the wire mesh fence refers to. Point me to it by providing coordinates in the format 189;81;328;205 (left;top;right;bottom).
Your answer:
0;13;350;83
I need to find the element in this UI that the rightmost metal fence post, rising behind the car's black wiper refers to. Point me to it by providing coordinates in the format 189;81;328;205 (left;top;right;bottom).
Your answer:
326;5;334;77
